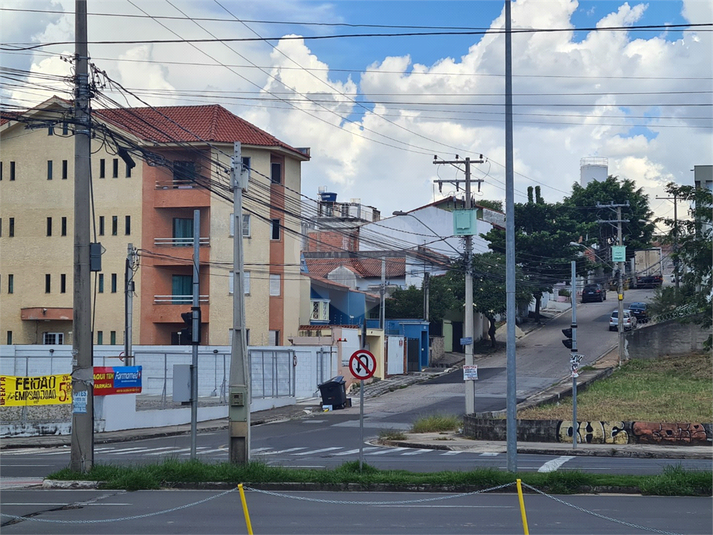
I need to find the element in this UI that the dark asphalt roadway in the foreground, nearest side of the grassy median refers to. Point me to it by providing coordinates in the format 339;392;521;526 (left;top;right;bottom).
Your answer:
2;489;713;535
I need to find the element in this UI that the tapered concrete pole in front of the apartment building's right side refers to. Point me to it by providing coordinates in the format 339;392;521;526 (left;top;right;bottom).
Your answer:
228;142;250;465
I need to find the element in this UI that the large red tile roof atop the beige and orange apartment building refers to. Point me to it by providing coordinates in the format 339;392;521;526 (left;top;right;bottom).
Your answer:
93;104;307;158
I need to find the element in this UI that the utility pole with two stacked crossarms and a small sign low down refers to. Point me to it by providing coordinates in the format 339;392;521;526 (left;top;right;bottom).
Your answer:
433;154;483;414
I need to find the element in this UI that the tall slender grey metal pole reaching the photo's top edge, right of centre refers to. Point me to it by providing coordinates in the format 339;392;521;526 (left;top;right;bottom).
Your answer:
505;0;517;472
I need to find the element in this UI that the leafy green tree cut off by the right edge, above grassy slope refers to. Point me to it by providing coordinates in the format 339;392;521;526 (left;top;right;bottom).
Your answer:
654;183;713;349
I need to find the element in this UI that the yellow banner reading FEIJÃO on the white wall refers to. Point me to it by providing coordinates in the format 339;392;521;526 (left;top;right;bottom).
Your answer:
0;374;72;407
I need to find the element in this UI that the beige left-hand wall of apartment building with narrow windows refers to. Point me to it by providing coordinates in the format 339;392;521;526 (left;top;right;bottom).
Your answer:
0;116;141;344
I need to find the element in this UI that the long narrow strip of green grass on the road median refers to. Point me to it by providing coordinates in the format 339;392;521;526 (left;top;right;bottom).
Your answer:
48;460;713;496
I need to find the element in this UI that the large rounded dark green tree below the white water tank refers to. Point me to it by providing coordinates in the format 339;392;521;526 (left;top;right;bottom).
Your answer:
563;176;655;258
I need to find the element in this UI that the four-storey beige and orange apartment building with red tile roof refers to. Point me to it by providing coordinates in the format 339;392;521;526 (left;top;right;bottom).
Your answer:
0;98;309;345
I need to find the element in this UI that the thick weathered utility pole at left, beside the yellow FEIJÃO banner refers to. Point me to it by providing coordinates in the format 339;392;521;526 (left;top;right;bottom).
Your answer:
70;0;94;473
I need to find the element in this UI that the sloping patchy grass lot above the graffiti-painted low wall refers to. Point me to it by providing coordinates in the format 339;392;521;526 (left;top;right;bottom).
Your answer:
518;353;713;422
